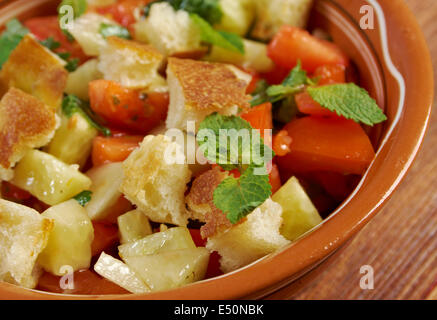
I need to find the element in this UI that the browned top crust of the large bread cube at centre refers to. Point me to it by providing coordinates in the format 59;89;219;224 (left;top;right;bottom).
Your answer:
168;58;249;110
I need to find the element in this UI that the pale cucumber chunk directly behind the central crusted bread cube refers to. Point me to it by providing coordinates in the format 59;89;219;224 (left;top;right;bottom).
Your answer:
205;39;275;73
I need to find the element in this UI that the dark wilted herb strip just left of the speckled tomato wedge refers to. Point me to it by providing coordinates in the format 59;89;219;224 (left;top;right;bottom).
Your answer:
62;94;112;137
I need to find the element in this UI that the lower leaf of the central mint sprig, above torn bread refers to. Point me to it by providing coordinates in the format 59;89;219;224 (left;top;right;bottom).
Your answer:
213;166;272;224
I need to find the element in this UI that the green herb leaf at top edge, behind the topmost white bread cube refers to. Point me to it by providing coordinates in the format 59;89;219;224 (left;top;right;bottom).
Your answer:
144;0;223;25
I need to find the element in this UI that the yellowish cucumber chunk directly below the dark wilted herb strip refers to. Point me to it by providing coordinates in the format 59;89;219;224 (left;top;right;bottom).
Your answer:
45;112;98;168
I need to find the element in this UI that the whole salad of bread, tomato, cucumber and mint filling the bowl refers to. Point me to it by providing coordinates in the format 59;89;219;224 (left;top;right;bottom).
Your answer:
0;0;387;295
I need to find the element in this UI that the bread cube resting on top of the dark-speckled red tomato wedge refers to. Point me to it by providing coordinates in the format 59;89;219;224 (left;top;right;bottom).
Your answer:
98;37;166;88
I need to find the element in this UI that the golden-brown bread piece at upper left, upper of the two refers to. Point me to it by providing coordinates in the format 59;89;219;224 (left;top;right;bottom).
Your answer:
0;35;68;110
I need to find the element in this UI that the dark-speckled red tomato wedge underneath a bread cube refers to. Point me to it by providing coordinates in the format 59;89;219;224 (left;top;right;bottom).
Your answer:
89;80;169;134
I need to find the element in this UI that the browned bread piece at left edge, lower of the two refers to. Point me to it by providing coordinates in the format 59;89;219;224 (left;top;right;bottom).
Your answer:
0;88;59;180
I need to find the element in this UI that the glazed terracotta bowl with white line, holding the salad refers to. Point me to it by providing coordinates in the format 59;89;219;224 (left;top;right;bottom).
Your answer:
0;0;433;299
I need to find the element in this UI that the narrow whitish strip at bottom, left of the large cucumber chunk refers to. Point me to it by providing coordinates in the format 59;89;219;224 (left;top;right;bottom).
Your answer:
94;252;151;293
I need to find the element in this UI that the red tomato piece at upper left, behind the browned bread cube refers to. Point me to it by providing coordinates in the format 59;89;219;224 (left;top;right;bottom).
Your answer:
24;16;88;63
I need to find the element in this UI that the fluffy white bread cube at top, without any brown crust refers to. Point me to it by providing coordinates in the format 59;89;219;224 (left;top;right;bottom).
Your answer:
135;2;203;56
